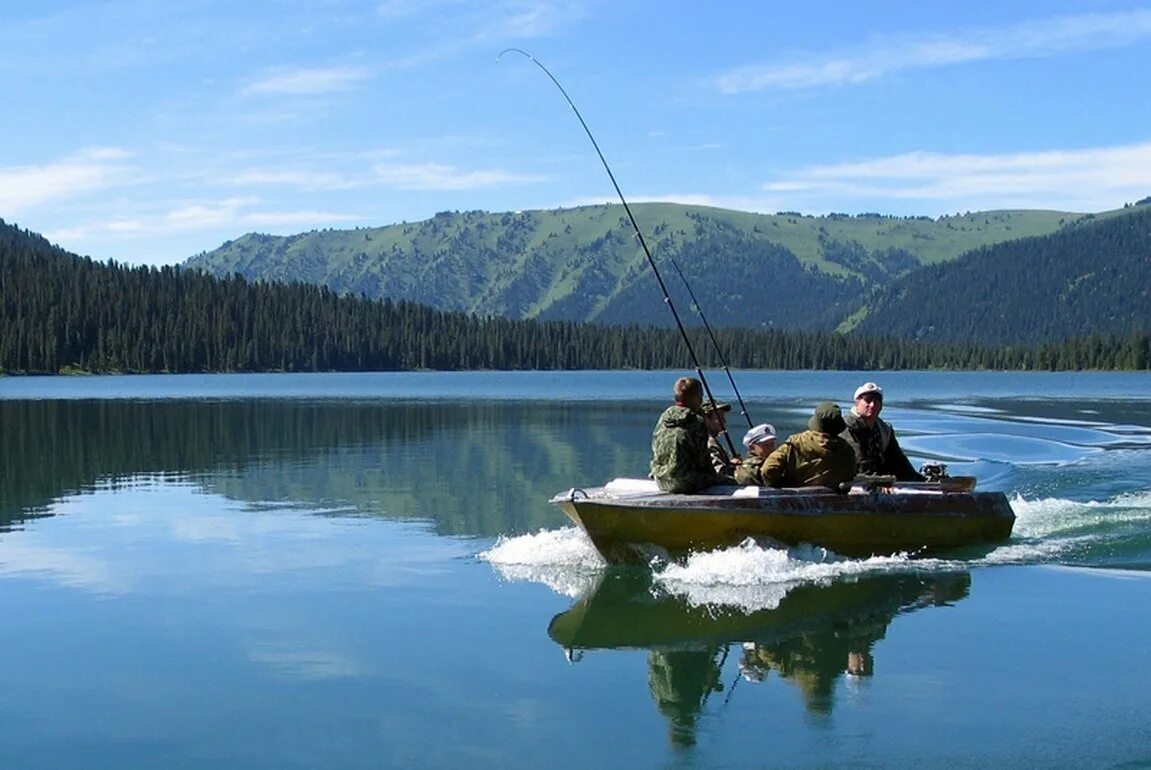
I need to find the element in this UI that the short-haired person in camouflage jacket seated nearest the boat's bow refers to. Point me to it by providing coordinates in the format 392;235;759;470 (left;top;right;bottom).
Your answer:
650;378;735;494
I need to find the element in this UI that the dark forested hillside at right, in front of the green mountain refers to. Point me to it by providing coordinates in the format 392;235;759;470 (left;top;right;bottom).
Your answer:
856;204;1151;346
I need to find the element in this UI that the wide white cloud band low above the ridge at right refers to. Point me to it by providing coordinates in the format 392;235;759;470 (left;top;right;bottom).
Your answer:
763;142;1151;211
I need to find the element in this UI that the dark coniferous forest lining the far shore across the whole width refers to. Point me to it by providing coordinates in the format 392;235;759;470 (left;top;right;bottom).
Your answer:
0;221;1151;374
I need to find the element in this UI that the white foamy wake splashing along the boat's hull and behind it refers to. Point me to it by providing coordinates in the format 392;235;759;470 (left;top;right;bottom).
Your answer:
479;490;1151;598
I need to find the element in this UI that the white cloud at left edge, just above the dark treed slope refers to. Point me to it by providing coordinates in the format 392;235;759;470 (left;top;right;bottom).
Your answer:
0;147;131;216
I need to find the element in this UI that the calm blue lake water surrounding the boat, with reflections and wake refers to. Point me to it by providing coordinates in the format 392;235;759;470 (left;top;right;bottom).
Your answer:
0;372;1151;770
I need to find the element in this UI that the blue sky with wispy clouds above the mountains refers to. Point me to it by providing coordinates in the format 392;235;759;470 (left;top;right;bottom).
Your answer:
0;0;1151;265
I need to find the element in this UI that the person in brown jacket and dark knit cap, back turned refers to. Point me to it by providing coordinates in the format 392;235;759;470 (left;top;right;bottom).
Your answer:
759;401;855;491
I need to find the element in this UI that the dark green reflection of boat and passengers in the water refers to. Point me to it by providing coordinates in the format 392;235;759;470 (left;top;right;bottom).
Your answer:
548;567;970;746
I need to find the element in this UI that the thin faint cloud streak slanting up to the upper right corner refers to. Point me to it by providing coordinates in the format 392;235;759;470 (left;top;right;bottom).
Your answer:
715;9;1151;93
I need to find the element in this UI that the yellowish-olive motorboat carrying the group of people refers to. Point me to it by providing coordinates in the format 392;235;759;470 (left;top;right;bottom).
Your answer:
550;477;1015;564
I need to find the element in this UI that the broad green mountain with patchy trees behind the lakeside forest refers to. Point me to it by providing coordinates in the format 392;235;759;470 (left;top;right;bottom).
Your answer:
185;204;1085;330
